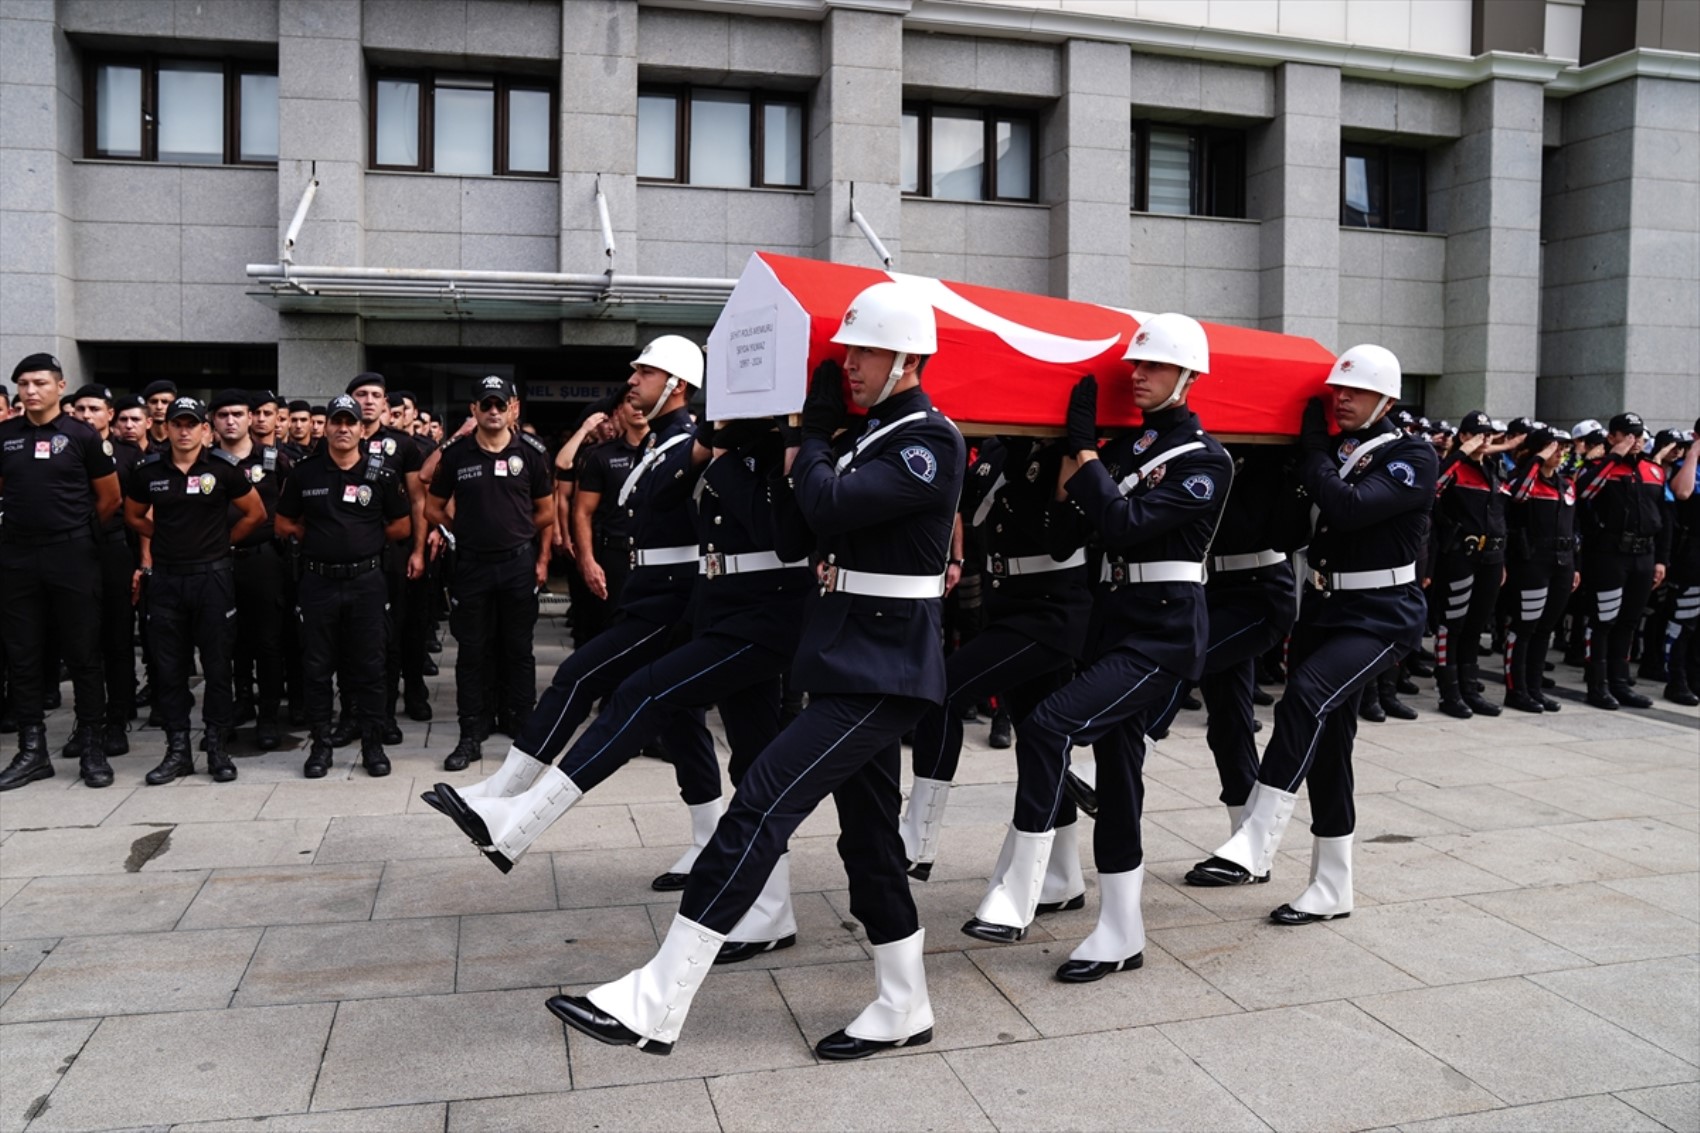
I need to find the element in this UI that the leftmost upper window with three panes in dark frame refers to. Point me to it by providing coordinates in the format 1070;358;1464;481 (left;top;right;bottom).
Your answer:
83;54;277;165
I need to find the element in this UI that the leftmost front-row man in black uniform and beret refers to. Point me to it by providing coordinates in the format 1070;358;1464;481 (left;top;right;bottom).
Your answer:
0;354;119;791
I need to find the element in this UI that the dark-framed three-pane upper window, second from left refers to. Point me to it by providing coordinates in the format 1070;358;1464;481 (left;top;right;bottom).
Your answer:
371;71;558;177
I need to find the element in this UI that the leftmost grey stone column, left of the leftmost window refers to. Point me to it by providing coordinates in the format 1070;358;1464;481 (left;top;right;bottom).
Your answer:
0;0;83;379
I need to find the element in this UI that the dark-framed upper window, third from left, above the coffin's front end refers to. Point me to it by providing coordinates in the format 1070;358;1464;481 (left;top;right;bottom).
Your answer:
638;87;804;189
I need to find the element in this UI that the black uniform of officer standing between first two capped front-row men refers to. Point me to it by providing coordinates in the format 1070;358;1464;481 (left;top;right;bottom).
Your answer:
231;444;294;749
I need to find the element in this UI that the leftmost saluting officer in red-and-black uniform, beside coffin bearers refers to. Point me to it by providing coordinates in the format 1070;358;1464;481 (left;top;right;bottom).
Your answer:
1428;410;1506;720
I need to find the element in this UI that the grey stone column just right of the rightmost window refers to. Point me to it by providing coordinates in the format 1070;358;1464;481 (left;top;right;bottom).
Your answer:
1428;78;1544;418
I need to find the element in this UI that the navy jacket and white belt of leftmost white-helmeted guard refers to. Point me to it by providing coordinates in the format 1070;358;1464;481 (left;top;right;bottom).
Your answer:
612;408;697;626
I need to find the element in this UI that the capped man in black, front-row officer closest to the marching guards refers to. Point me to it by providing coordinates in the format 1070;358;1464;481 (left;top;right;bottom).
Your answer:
425;374;554;766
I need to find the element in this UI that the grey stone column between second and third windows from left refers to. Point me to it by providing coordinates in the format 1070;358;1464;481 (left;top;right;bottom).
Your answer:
559;0;638;345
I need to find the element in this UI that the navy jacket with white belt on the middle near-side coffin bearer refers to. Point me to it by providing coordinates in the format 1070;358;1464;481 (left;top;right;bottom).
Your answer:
1064;405;1234;680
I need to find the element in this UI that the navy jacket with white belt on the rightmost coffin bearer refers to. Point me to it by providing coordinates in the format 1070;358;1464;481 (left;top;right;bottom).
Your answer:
1299;418;1440;650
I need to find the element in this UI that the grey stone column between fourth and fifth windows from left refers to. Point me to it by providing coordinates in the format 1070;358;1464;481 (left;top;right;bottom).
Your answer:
1040;39;1132;306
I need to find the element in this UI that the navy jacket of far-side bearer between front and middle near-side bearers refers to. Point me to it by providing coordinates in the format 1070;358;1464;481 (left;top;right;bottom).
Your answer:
961;437;1091;658
